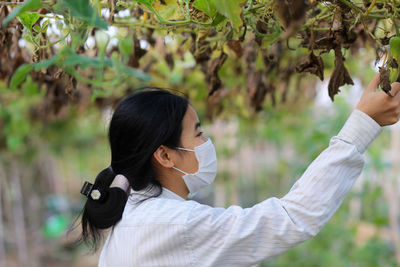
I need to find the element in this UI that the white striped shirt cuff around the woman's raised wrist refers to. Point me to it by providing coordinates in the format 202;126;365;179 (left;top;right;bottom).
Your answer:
337;109;382;154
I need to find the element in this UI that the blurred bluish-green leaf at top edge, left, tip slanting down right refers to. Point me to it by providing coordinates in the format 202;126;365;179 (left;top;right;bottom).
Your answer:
59;0;108;29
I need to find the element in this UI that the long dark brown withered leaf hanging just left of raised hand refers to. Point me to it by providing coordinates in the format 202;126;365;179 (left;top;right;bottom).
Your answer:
328;47;354;101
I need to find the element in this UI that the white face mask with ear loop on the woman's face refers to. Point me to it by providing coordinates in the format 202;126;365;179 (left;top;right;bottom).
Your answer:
172;138;217;197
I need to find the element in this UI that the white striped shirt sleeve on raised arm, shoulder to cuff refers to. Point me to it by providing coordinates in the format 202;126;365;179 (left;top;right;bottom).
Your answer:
186;109;382;266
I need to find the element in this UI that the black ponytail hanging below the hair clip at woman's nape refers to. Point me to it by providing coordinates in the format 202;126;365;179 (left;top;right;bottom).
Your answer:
81;166;128;250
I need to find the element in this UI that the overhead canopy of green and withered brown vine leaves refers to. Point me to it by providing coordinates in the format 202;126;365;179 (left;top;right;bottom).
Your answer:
0;0;400;124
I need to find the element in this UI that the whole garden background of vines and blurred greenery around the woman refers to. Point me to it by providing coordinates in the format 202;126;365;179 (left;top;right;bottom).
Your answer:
0;0;400;266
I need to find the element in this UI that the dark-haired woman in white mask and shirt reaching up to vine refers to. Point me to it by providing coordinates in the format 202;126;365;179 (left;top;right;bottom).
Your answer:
82;74;400;267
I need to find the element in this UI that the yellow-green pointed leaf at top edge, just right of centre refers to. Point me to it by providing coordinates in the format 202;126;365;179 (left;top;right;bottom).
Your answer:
214;0;244;32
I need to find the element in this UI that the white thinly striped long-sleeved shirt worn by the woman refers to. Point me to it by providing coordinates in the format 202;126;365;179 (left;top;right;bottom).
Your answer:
99;109;382;267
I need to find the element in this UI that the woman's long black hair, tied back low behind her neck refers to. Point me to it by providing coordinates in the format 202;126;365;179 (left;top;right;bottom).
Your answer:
73;87;189;251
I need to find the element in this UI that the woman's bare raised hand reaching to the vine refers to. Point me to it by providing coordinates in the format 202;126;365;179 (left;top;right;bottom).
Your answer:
356;73;400;126
